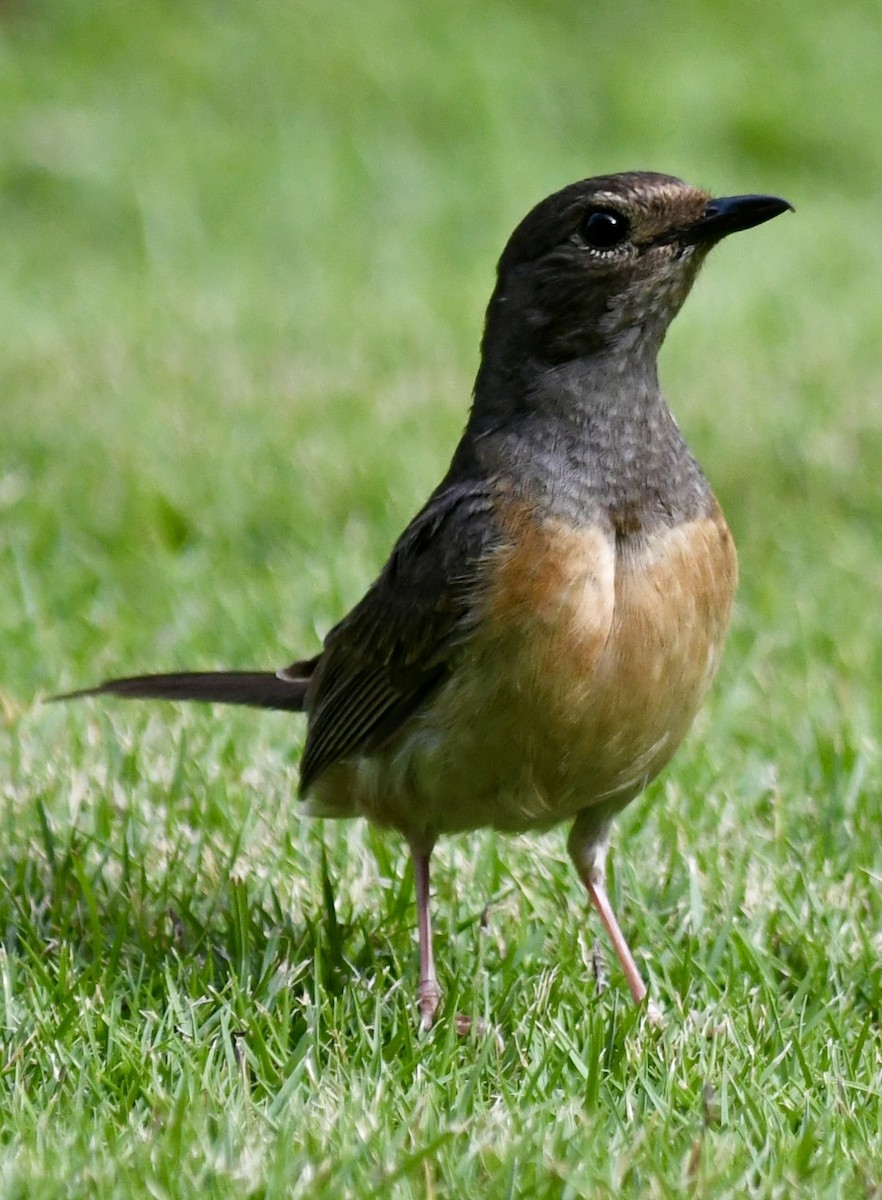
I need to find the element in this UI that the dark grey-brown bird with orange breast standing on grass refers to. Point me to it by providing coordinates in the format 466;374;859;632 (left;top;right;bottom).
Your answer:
53;172;792;1028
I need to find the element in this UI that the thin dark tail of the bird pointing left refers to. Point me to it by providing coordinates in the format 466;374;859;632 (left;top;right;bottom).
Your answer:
49;659;317;713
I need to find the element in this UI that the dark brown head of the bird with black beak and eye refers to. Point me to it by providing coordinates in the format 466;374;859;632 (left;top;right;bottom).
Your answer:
485;172;791;364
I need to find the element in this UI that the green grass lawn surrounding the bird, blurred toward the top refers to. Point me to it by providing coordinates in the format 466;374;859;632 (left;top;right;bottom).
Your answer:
0;0;882;1200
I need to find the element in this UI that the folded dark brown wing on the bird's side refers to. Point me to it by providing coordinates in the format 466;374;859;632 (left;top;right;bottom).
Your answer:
300;482;499;793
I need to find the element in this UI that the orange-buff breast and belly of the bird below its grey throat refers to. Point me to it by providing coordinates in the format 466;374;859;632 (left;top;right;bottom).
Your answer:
312;512;737;836
